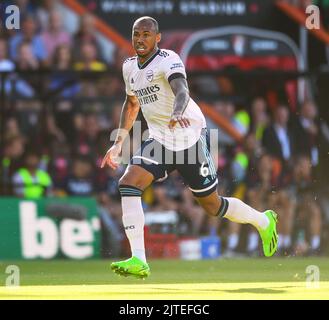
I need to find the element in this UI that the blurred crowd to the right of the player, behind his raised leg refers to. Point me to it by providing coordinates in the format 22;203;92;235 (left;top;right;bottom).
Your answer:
213;97;328;256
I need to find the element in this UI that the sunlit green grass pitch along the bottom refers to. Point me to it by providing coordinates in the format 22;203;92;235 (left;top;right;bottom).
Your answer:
0;258;329;300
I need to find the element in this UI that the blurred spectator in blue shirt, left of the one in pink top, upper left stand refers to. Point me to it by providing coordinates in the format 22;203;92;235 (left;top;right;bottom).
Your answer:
9;15;48;63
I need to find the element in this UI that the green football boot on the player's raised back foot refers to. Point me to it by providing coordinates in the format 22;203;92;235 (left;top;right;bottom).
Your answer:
258;210;279;257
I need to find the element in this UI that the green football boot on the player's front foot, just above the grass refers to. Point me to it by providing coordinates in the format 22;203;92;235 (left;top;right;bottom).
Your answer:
111;257;151;279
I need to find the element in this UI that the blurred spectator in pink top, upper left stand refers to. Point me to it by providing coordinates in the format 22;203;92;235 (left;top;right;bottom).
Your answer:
41;10;71;59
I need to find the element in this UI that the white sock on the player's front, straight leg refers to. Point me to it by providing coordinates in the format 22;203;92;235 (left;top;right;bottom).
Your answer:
121;197;146;262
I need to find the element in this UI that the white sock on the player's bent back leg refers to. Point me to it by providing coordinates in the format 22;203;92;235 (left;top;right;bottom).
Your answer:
223;197;270;229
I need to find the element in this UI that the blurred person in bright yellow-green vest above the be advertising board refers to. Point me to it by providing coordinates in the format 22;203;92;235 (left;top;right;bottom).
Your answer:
12;150;52;199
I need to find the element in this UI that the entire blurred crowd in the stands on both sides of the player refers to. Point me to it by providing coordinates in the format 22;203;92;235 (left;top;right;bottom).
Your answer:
0;0;328;256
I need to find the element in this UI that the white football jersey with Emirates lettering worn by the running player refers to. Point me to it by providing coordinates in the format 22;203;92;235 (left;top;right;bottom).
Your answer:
122;49;206;151
